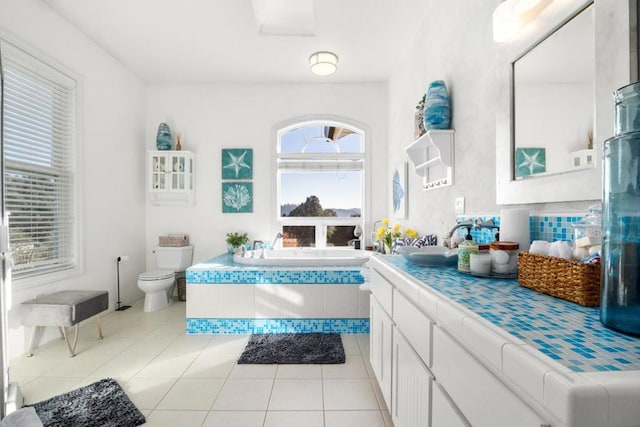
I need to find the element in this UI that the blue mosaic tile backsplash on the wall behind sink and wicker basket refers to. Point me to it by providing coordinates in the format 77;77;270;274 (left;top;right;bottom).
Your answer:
458;215;583;243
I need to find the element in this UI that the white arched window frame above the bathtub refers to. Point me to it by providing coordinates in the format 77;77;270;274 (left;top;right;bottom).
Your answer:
274;118;370;249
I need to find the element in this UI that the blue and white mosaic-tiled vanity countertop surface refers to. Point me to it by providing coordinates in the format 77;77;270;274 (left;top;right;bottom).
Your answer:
384;255;640;372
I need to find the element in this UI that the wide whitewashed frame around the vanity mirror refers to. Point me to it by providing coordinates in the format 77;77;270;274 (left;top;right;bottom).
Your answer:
496;0;637;205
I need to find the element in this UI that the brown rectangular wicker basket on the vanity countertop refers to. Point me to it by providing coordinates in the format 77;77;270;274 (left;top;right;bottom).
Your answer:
518;252;600;307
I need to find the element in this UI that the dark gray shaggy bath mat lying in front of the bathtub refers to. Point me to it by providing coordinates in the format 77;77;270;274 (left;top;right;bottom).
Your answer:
238;333;344;365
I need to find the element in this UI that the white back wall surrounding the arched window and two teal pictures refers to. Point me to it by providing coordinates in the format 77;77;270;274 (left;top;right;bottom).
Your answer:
145;83;390;267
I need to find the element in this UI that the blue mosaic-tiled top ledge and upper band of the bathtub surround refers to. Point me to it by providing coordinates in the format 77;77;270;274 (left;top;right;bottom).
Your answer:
186;254;364;285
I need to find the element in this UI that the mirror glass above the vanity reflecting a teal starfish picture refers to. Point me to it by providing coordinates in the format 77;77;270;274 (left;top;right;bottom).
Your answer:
513;5;595;179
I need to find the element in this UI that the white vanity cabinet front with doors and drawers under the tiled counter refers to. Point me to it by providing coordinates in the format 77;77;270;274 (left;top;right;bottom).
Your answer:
370;260;550;427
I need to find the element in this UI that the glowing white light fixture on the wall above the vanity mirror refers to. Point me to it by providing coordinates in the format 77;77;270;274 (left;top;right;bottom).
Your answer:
493;0;552;43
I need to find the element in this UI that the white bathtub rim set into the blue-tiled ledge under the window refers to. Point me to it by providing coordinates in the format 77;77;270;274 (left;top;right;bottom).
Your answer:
233;248;370;266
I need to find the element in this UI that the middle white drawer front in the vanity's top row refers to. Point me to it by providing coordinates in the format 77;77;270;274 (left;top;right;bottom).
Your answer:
393;291;431;366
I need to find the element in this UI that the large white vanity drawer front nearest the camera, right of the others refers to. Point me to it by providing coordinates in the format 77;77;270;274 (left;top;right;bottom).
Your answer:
432;327;548;427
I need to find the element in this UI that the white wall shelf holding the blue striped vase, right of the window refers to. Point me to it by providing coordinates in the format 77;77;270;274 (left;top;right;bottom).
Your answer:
405;129;455;190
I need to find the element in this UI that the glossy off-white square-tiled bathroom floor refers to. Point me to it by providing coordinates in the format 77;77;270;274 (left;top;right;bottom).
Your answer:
10;302;393;427
